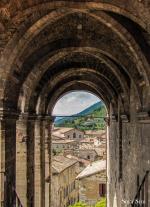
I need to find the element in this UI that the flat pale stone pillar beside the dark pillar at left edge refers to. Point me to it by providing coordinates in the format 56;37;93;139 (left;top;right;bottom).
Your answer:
16;114;28;206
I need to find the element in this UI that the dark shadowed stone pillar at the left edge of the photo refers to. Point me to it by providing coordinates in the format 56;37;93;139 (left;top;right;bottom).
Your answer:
0;111;17;207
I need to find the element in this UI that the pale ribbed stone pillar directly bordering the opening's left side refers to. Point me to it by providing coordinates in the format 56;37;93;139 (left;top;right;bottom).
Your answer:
34;116;52;207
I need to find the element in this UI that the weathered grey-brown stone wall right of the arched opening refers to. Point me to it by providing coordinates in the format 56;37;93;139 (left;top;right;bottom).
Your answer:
107;83;150;207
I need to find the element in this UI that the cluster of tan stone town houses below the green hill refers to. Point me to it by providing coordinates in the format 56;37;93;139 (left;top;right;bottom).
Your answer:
51;127;106;207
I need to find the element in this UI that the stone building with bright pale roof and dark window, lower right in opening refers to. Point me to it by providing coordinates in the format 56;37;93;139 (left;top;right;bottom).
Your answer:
77;160;106;206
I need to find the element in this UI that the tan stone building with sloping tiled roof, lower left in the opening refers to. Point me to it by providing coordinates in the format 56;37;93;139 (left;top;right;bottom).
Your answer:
51;156;79;207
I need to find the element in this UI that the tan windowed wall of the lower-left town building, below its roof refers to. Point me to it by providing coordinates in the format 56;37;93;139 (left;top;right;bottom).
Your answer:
51;162;79;207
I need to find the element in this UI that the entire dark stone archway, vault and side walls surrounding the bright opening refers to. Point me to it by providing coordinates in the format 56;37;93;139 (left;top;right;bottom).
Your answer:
0;0;150;207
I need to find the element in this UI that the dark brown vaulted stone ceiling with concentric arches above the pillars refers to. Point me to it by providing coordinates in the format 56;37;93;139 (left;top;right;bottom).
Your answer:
0;0;150;113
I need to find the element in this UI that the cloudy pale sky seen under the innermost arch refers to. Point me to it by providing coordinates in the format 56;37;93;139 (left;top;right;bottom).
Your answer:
53;91;100;115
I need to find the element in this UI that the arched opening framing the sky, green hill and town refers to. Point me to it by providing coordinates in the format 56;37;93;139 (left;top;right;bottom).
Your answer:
51;91;108;207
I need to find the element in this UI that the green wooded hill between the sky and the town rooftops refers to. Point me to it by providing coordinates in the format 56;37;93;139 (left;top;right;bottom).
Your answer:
55;102;106;130
